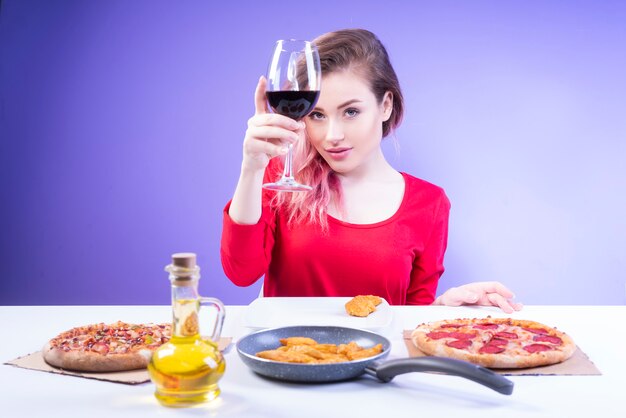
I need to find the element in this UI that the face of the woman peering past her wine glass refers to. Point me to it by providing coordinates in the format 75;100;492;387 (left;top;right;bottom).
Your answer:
305;71;392;174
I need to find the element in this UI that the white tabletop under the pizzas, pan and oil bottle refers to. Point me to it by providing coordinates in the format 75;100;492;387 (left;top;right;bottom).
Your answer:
0;306;626;418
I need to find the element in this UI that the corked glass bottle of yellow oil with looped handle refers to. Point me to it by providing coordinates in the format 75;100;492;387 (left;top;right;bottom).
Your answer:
148;253;226;407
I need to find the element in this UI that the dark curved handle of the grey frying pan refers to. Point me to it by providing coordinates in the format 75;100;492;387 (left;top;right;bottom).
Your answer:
365;357;513;395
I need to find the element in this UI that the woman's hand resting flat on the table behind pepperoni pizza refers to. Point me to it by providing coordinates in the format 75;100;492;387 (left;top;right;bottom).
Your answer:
433;282;523;313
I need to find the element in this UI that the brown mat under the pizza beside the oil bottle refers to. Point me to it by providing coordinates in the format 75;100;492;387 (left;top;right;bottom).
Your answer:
4;337;232;385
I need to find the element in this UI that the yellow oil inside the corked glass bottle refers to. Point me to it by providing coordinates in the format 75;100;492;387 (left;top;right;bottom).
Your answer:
148;299;226;407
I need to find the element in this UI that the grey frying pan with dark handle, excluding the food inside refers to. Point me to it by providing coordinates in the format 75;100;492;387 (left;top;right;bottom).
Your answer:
237;326;513;395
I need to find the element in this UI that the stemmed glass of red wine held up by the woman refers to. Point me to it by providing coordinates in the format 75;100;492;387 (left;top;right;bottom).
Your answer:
263;39;322;192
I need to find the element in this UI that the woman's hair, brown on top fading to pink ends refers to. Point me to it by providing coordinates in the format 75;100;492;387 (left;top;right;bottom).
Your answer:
271;29;404;231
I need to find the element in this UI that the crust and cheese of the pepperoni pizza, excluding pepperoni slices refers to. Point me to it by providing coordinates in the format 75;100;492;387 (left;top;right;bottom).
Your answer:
411;317;576;369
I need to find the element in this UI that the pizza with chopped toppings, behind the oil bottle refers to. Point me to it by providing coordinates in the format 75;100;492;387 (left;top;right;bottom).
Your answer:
43;321;171;372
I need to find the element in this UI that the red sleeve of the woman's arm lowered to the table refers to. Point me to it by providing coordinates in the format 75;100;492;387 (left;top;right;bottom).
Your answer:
406;191;450;305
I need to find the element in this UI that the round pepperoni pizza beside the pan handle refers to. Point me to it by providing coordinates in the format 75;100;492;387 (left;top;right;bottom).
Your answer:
411;317;576;369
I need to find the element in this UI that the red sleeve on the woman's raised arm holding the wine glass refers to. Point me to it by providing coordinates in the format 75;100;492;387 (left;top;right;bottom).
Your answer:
220;202;275;286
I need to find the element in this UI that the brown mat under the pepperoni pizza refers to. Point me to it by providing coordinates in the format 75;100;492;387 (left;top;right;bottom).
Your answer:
402;330;602;376
